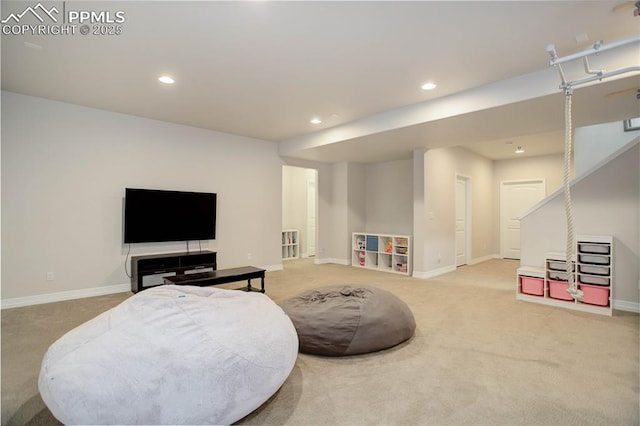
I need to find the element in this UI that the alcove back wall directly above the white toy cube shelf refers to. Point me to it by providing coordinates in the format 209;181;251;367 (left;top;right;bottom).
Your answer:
364;160;413;235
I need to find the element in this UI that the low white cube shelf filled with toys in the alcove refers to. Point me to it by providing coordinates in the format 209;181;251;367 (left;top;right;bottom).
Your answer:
351;232;411;275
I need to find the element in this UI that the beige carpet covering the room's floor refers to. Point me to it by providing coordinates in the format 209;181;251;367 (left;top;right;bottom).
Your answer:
2;260;640;425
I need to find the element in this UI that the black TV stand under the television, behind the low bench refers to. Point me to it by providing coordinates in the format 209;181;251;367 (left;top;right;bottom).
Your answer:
131;250;217;293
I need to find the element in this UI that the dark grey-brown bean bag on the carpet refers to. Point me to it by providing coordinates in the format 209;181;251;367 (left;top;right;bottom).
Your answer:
282;285;416;356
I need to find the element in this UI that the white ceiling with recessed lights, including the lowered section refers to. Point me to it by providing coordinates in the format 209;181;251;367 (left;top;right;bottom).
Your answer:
0;0;640;162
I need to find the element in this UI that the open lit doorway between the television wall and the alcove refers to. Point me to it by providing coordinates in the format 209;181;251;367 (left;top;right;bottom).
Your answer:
282;166;318;258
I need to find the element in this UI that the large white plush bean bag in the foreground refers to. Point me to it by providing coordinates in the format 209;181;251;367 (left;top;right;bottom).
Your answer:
38;286;298;425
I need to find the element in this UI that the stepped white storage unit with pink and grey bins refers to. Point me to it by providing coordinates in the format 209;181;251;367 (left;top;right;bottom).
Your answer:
516;235;613;315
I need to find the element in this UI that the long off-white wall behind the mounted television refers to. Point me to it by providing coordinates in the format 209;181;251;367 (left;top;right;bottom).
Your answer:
2;92;283;301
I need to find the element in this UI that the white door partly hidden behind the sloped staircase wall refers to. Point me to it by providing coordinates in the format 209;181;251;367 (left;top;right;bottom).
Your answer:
500;179;544;259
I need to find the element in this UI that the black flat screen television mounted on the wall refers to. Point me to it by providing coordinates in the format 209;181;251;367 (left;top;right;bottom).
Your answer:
124;188;217;244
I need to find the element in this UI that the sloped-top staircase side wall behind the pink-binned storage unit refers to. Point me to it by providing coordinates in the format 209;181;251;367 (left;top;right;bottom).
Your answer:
521;144;640;307
